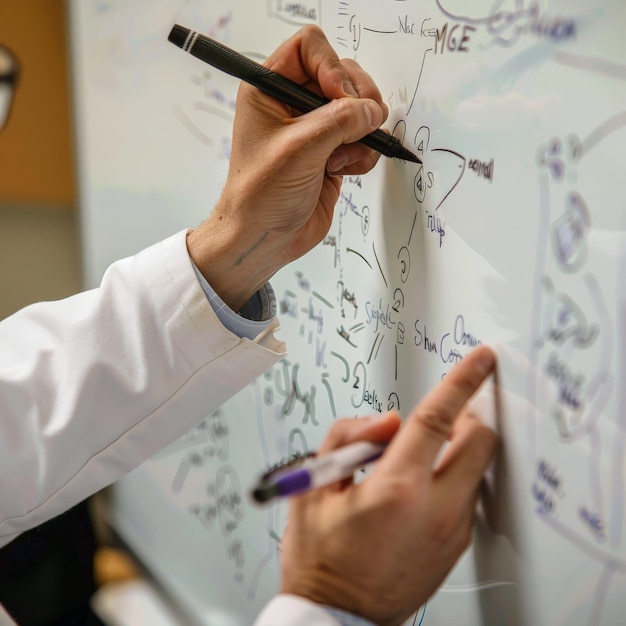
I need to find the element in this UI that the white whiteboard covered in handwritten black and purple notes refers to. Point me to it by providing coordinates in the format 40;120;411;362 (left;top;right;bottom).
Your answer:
68;0;626;626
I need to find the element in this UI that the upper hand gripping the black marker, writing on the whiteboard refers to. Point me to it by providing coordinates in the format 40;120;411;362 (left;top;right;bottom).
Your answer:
188;26;387;310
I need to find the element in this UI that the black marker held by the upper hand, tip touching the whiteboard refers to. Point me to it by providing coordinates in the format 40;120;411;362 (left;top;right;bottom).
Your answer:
168;24;422;163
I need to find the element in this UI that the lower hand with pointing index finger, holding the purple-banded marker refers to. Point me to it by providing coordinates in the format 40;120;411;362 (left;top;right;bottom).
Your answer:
281;346;497;626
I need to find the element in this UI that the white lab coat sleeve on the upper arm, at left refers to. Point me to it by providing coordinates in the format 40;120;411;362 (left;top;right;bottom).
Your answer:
0;232;285;545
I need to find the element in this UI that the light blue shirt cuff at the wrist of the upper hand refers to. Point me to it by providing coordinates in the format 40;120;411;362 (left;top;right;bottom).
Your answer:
192;263;276;340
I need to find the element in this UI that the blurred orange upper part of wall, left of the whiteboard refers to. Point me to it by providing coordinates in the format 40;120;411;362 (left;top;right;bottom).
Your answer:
0;0;75;210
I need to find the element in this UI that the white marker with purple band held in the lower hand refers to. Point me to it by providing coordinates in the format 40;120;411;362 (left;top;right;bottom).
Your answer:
252;441;385;502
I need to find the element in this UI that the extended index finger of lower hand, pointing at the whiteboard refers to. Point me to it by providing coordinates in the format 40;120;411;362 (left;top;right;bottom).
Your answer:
379;346;495;473
